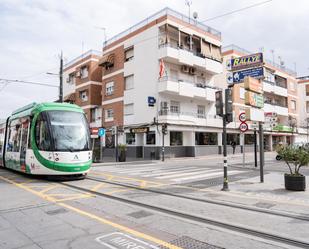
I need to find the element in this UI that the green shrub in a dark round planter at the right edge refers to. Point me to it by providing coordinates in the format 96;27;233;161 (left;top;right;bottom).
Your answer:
277;146;309;191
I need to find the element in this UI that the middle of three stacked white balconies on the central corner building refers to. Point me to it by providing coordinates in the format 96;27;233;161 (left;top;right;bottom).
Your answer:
158;77;216;102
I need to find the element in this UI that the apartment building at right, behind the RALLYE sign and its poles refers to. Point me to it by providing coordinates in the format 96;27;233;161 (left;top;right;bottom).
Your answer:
216;45;299;150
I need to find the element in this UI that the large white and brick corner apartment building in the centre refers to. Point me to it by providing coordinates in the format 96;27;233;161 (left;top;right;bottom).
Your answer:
99;8;222;158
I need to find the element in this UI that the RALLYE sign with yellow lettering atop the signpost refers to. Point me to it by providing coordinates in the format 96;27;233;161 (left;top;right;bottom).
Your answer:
226;53;264;71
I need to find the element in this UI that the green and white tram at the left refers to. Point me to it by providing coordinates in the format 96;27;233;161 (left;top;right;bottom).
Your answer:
0;103;92;175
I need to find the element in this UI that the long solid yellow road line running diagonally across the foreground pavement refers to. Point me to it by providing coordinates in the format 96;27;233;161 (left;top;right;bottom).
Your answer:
0;176;182;249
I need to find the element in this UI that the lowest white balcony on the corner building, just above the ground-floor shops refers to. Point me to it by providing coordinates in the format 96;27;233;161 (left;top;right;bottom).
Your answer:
159;110;222;127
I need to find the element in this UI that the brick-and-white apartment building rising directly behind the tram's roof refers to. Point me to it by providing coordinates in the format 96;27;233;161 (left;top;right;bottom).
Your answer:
63;50;102;127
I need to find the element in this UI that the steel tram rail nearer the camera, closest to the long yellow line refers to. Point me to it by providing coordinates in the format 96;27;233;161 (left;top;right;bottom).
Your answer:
59;177;309;248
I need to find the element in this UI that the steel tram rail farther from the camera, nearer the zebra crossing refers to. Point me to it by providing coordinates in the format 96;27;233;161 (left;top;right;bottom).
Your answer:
86;176;309;221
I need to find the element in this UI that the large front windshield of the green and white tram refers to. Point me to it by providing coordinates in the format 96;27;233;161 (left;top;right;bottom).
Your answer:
47;111;90;152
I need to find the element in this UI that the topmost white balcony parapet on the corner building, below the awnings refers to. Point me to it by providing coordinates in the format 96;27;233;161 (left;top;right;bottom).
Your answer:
159;43;223;74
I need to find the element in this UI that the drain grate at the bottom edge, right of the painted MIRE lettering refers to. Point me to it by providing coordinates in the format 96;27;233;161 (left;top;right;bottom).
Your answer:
159;236;223;249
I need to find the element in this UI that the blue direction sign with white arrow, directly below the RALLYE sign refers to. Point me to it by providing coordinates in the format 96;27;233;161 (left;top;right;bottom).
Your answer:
226;67;264;84
